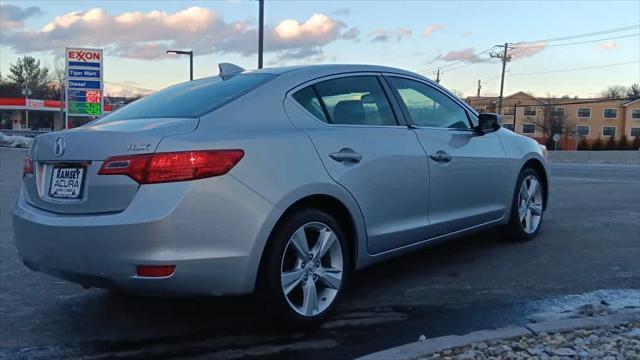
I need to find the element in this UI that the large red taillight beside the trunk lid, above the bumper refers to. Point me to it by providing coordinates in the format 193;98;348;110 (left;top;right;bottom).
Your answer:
98;150;244;184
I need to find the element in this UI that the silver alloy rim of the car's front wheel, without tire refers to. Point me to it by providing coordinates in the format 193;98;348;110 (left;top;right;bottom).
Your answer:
518;175;543;234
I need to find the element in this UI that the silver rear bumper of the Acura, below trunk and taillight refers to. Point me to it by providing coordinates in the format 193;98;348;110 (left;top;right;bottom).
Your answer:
13;176;273;295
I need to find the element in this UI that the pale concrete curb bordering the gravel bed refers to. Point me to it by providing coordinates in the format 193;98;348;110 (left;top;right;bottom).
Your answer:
356;311;640;360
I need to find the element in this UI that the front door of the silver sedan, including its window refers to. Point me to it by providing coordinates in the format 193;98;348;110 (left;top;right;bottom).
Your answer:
386;75;509;237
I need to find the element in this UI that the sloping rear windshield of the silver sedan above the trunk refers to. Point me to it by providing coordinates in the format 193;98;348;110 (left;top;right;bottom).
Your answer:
94;74;275;124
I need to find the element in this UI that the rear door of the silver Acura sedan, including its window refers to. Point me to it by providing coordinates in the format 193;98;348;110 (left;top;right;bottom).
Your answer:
285;74;429;254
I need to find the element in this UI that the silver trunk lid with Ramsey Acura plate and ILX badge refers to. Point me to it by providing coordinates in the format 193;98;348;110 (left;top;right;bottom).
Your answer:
24;118;198;214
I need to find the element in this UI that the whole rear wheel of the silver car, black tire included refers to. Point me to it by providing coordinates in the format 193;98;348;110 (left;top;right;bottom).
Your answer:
257;208;351;327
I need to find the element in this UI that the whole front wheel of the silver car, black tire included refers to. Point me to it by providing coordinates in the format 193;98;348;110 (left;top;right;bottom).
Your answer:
502;168;547;242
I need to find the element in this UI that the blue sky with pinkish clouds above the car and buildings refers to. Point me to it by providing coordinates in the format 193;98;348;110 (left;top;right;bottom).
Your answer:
0;0;640;97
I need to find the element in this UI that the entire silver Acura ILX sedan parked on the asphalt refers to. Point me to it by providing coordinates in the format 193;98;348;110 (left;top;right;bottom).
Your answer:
13;64;549;324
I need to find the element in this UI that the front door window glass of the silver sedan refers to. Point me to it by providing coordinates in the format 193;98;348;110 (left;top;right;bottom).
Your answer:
389;77;470;129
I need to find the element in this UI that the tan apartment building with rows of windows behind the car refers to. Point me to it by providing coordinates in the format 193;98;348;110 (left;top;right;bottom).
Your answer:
466;92;640;149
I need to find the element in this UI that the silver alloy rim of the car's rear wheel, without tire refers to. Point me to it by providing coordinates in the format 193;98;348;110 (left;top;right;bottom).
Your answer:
280;222;344;316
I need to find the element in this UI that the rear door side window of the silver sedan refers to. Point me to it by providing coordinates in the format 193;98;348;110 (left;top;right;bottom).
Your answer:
293;76;398;126
